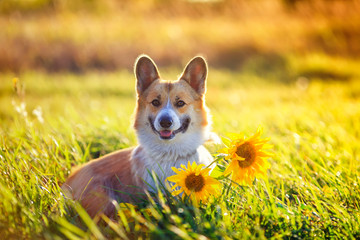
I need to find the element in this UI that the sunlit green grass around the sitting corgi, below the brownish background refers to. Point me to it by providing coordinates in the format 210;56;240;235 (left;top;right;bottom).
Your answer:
0;63;360;239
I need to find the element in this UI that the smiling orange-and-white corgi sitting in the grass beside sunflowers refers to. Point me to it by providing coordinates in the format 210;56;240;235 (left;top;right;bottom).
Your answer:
62;55;214;217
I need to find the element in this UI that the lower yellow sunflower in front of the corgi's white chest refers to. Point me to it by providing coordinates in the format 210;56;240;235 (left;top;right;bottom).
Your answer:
167;162;221;203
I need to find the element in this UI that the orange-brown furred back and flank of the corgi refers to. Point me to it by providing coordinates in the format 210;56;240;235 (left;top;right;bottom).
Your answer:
63;148;143;217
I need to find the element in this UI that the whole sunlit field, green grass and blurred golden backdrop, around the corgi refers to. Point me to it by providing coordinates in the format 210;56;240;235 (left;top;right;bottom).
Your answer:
0;0;360;239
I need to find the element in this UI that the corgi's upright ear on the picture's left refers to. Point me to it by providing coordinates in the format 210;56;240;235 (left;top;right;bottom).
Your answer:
135;55;160;93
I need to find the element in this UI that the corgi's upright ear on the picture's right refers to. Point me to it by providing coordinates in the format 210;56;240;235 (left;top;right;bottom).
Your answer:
180;57;207;95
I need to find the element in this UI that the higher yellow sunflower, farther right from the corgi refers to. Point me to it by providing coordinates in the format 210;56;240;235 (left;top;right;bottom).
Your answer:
219;127;273;184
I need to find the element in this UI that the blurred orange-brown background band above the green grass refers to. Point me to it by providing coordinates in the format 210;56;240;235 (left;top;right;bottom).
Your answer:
0;0;360;79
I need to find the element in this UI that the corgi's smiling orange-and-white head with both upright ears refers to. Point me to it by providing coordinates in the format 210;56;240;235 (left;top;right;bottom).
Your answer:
134;55;209;153
